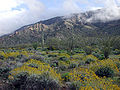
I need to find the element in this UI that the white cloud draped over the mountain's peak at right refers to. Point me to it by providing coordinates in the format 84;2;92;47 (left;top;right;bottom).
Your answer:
88;0;120;22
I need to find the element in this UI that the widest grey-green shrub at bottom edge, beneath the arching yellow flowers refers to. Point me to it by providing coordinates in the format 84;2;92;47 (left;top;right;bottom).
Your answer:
24;72;60;90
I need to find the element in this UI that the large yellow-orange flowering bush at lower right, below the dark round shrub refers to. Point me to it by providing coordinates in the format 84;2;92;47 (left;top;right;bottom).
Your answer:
69;68;120;90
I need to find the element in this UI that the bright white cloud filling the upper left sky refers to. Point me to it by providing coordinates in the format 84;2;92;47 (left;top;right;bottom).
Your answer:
0;0;45;35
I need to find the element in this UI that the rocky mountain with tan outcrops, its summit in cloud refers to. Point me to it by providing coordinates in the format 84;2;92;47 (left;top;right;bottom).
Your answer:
0;10;120;46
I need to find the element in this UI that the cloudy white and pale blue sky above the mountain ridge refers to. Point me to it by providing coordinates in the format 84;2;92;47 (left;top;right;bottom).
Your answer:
0;0;120;35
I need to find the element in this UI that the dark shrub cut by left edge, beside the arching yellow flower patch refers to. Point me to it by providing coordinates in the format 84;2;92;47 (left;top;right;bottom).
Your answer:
0;67;11;78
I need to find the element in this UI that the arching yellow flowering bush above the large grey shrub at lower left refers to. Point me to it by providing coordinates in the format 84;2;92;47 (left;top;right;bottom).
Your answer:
9;59;62;81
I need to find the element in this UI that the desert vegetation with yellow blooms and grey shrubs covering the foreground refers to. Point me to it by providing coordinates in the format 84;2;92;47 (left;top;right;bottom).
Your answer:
0;36;120;90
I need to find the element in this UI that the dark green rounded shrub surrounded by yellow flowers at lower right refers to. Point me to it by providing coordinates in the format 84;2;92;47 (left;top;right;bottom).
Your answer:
95;67;114;77
